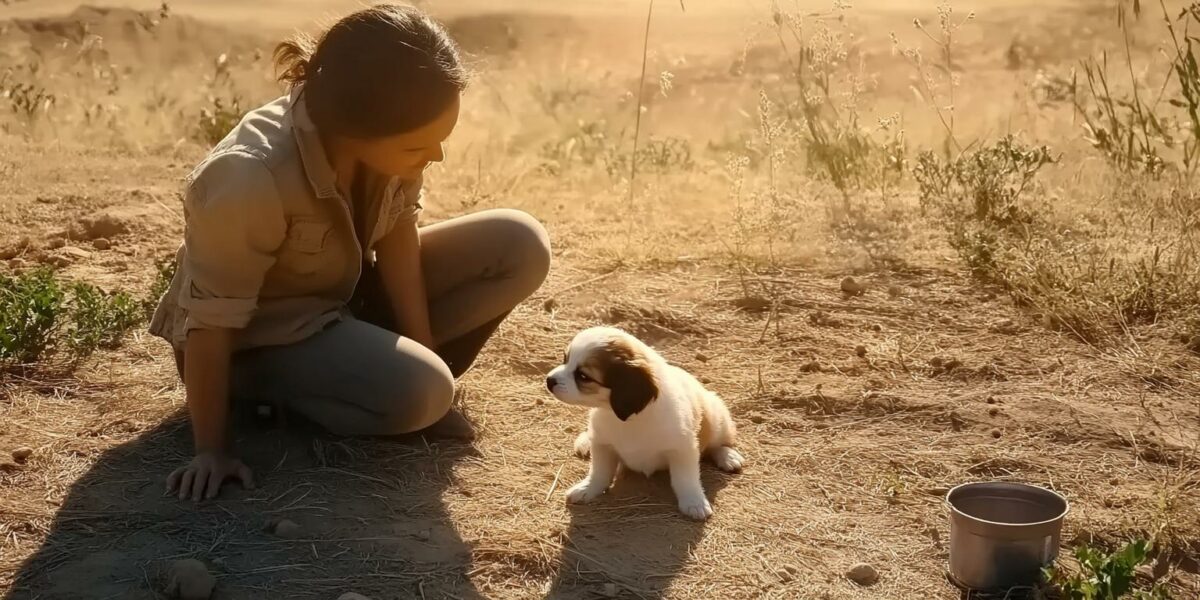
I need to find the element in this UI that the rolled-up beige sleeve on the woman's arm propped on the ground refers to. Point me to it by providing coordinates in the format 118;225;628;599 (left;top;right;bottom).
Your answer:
179;151;287;335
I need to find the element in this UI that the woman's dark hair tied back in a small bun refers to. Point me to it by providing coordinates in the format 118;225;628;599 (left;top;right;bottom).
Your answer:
275;4;467;139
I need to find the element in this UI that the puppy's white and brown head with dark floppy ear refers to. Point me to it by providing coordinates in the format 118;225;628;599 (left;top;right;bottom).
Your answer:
546;328;659;421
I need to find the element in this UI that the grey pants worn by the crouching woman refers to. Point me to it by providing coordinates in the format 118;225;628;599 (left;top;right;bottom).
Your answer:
177;210;550;436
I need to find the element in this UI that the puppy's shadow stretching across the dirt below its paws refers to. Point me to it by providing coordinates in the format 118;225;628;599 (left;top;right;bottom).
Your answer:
546;460;742;600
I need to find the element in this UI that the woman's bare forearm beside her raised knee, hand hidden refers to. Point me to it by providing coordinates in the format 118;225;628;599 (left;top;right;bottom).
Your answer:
376;222;434;350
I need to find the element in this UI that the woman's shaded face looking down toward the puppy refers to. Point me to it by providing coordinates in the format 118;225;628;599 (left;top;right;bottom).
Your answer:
347;97;458;179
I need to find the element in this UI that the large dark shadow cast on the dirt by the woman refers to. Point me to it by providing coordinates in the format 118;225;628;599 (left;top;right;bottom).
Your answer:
5;414;482;600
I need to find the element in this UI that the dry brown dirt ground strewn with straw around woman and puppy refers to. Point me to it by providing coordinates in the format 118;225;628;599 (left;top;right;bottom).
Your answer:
0;0;1200;600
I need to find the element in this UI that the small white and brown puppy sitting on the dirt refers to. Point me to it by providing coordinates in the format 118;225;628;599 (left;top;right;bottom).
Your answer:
546;326;743;520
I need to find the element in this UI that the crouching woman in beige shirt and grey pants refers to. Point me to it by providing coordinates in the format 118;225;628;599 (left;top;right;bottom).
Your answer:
151;5;550;500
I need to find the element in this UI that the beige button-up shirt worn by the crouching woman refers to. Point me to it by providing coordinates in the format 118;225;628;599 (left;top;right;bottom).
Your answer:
150;86;421;348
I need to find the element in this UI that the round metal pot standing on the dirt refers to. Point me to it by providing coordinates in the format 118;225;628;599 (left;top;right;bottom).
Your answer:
946;481;1070;590
